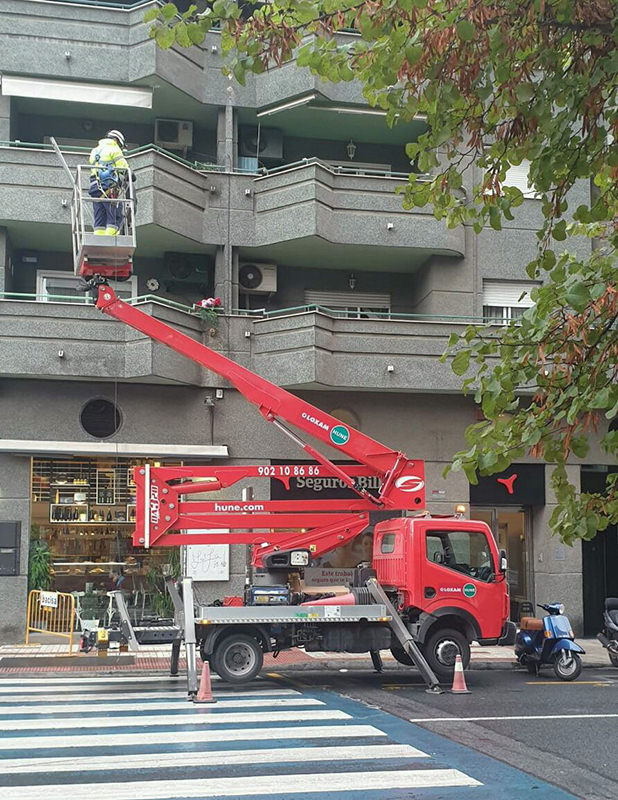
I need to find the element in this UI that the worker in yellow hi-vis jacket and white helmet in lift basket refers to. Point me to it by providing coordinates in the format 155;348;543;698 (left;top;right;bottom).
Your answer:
88;130;129;236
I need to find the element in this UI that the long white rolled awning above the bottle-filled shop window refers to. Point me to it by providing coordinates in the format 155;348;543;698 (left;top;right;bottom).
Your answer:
0;439;229;460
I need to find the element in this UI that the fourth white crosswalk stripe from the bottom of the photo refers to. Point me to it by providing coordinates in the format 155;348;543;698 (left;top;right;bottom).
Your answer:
1;706;350;731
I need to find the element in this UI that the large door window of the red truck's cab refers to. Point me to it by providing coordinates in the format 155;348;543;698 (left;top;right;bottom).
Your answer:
427;531;495;582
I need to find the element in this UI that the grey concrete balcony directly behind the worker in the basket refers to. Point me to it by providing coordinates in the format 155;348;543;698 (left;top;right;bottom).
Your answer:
0;146;237;256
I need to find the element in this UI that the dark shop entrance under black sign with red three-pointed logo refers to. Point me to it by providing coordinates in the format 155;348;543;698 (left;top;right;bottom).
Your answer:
470;464;545;620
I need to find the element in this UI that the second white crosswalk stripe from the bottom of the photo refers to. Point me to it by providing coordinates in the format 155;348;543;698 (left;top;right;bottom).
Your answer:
0;744;429;772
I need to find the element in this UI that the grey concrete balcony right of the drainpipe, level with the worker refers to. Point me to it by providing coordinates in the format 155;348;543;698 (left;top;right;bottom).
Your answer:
254;160;465;257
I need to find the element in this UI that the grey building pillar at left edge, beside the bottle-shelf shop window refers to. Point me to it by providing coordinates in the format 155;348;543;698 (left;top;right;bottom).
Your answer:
0;454;30;644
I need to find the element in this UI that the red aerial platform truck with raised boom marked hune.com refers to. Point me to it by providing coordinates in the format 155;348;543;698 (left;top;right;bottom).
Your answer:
83;276;515;694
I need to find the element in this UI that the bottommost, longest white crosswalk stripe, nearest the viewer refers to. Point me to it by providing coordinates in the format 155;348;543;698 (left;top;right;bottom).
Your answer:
2;769;482;800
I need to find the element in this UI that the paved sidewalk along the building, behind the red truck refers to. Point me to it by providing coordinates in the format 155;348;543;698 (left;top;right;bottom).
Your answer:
0;638;610;675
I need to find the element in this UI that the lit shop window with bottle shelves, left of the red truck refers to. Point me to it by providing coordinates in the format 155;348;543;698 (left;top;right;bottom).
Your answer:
31;458;177;617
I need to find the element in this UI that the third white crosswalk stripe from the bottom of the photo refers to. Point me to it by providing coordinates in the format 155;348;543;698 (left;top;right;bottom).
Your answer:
0;725;386;752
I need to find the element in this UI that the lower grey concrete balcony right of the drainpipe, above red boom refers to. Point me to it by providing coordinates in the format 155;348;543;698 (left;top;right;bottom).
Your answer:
251;311;463;393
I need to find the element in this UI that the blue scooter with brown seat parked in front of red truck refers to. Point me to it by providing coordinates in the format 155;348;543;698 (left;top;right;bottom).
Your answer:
515;601;584;681
